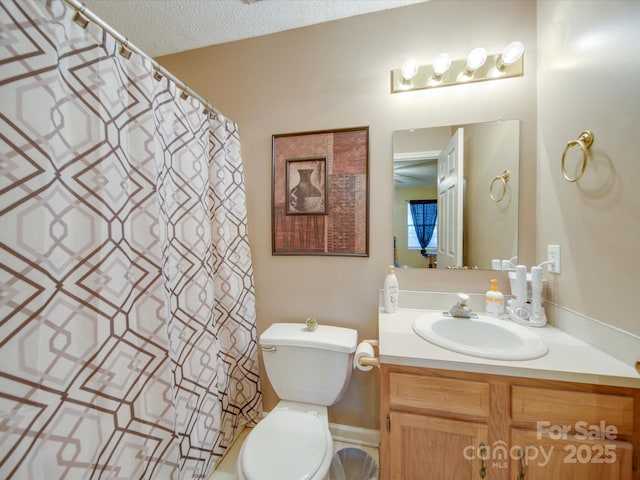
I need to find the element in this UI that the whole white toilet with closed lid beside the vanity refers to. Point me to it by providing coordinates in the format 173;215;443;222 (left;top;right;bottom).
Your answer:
236;323;358;480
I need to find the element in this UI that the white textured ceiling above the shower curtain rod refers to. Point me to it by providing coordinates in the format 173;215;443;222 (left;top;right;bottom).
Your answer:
80;0;428;57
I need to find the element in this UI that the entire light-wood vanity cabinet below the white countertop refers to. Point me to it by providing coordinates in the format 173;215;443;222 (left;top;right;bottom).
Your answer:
380;364;640;480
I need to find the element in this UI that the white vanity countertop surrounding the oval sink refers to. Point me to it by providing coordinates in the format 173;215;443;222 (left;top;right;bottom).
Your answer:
378;308;640;388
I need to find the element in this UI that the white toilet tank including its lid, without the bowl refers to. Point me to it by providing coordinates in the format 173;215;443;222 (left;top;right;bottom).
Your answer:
260;323;358;406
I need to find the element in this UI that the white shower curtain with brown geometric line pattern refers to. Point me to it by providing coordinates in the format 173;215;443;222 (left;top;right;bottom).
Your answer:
0;0;261;480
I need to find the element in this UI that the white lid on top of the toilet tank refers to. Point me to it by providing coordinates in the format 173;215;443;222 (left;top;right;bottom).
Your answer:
260;323;358;353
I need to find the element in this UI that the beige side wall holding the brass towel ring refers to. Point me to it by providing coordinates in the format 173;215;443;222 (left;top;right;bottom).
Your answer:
537;0;640;336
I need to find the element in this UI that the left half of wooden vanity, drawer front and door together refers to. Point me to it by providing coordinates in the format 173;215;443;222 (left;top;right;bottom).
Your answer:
388;372;489;480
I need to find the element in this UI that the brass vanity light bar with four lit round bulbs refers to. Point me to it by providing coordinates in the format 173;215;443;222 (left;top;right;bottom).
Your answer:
391;42;524;93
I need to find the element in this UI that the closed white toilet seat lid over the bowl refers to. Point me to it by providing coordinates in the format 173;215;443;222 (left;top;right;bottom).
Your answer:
242;410;328;480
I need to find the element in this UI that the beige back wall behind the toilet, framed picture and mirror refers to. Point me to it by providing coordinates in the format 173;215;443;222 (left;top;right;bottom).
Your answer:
159;0;537;428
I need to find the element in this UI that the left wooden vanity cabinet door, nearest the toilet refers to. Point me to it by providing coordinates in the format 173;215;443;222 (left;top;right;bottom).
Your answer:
389;411;488;480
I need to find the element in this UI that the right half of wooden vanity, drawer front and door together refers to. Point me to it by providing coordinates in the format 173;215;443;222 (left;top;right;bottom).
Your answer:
511;385;634;480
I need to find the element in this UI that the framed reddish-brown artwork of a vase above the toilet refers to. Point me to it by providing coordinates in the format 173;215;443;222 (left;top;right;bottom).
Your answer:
271;127;369;257
